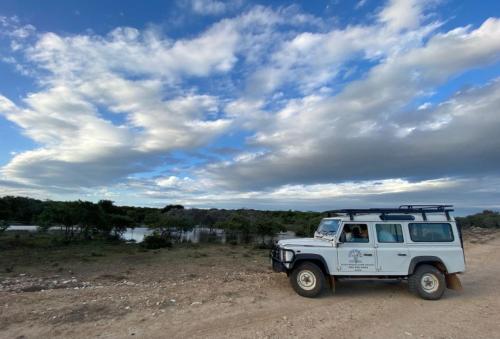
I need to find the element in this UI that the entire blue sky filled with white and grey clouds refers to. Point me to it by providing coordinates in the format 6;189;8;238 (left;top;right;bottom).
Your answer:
0;0;500;213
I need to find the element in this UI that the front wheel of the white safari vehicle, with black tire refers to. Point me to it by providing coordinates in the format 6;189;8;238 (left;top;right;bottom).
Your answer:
290;262;325;298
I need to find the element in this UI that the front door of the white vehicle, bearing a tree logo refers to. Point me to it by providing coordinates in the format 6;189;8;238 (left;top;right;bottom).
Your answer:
337;222;376;275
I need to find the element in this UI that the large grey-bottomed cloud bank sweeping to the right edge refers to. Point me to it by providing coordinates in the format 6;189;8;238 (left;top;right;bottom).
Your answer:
201;19;500;189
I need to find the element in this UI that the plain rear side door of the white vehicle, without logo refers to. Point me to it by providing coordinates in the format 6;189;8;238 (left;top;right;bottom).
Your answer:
375;223;410;275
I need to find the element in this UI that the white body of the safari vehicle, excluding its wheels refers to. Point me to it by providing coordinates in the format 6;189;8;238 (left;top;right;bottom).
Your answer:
272;205;465;298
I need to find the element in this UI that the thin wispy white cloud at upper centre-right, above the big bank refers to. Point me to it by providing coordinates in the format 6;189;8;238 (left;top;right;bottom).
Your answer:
243;5;441;95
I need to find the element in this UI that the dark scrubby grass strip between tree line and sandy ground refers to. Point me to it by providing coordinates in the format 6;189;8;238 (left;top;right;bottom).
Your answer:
0;232;274;278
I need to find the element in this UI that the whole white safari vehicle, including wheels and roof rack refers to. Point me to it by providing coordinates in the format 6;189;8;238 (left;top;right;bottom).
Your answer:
271;205;465;300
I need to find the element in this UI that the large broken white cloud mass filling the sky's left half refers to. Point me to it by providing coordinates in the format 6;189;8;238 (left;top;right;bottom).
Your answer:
0;7;296;189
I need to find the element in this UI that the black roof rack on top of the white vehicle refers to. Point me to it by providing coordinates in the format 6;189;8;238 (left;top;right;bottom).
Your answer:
324;205;453;221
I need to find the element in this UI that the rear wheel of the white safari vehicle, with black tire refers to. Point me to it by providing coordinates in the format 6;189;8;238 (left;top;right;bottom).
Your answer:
408;265;446;300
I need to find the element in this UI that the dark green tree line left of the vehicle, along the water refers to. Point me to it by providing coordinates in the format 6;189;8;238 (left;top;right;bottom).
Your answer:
0;196;322;241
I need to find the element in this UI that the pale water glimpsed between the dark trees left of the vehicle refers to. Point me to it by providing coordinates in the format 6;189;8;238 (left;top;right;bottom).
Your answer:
7;225;296;244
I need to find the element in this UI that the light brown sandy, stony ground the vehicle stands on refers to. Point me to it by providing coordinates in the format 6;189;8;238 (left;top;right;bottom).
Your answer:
0;232;500;338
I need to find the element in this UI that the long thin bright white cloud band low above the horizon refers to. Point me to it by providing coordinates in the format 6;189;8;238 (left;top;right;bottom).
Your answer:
132;176;460;210
